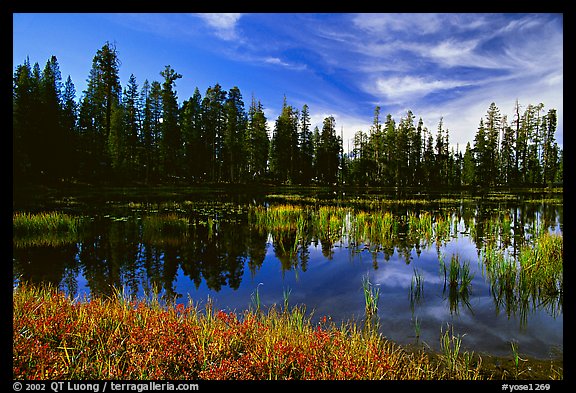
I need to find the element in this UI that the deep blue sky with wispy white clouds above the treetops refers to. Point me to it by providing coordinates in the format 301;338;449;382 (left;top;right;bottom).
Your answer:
13;13;563;149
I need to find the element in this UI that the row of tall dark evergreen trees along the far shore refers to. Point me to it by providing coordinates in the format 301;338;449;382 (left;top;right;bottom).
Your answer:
12;42;563;187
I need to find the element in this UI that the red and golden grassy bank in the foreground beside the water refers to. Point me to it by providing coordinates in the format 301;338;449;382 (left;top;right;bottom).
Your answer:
13;284;557;380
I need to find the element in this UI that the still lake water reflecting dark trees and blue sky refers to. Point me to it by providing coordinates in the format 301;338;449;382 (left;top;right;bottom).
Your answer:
13;188;563;359
